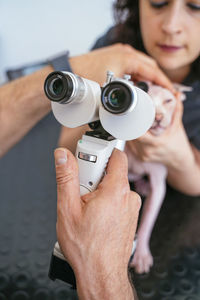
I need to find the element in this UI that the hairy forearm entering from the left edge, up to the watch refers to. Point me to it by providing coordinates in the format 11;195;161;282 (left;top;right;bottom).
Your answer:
0;66;53;157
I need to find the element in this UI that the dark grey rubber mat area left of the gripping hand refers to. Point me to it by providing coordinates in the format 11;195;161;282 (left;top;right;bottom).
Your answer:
0;114;77;300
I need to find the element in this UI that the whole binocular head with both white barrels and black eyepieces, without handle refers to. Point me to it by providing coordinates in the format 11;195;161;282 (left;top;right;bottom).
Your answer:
44;72;155;141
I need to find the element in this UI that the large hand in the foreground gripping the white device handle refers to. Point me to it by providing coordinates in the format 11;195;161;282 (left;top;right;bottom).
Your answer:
55;148;140;299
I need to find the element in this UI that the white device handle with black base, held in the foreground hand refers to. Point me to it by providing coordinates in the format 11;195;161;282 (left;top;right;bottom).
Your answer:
49;135;125;288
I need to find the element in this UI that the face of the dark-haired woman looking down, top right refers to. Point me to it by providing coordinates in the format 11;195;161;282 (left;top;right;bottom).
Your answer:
139;0;200;81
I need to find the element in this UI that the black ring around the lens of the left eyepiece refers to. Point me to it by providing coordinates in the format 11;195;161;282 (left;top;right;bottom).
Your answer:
44;71;73;103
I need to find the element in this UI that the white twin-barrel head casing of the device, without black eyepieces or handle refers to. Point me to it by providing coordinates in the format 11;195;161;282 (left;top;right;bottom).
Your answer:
51;72;155;141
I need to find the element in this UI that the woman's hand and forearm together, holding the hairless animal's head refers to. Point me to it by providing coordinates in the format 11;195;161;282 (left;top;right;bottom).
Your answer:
127;97;200;196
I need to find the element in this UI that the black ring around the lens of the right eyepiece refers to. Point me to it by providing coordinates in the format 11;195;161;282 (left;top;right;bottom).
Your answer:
101;81;134;114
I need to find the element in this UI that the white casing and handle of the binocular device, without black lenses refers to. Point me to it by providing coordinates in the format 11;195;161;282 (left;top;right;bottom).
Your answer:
48;72;155;270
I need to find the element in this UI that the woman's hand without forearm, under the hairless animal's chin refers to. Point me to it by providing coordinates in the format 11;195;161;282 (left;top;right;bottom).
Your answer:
127;95;191;168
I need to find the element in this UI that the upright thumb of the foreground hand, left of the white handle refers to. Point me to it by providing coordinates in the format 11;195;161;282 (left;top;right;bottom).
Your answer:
54;148;81;211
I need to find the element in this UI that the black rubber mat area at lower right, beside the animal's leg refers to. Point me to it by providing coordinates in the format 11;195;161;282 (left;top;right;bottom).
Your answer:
130;187;200;300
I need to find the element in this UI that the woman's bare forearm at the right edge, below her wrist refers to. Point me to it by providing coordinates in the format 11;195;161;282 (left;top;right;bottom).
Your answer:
167;145;200;196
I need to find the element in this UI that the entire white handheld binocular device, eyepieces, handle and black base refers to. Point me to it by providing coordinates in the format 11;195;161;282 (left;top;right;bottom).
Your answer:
44;71;155;287
